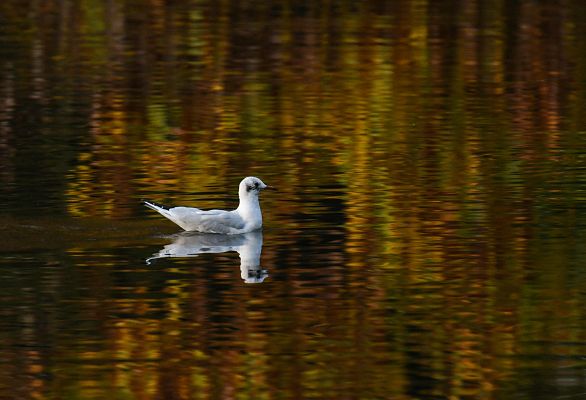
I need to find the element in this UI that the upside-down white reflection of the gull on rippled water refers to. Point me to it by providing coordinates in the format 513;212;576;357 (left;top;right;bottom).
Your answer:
146;230;269;283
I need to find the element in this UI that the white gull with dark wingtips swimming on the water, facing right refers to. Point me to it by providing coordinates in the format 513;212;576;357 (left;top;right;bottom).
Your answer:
144;176;269;235
